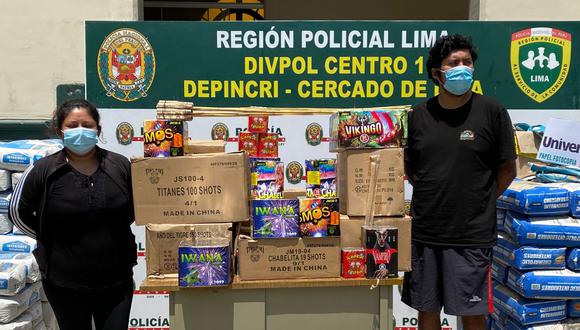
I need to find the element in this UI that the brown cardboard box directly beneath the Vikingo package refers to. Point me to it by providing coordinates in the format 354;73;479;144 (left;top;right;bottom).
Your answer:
337;148;405;216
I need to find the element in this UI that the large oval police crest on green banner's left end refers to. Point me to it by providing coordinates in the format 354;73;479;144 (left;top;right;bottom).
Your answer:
97;29;155;102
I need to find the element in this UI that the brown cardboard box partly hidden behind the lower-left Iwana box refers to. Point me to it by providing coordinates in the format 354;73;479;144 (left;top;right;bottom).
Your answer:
145;223;232;277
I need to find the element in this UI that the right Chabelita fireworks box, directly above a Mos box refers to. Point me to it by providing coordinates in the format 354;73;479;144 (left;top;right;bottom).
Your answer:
306;159;336;198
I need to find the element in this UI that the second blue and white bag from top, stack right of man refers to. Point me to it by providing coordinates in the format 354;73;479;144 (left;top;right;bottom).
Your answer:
505;211;580;247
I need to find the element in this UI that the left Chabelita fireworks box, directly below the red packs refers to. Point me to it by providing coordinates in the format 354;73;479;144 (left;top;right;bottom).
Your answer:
250;160;284;199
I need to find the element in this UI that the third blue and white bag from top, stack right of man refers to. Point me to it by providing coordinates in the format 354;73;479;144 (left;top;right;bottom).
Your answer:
493;234;566;270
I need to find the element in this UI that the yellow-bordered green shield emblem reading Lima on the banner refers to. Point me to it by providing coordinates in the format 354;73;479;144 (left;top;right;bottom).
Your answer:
510;27;572;103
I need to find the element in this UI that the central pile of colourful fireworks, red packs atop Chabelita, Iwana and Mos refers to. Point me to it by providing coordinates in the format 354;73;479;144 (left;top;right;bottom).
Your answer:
239;116;340;239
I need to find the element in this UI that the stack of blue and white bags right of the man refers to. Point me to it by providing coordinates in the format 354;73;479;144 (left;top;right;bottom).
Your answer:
490;179;580;329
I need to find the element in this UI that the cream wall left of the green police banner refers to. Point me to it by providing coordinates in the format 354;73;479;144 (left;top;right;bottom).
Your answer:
0;0;138;119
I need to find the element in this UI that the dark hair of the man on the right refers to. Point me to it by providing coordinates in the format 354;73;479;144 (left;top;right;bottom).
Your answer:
427;34;477;84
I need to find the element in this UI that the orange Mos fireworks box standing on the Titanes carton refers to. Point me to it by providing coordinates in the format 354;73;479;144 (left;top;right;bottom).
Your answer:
143;119;188;157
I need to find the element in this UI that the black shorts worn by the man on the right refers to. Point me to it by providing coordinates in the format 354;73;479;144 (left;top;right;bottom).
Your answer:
402;243;493;316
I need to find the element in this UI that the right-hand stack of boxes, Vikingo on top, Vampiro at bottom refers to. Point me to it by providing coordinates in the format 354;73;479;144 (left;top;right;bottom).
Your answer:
330;110;407;279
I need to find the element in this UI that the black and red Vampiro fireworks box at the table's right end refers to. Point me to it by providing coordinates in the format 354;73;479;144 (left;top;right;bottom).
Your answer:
362;226;399;278
